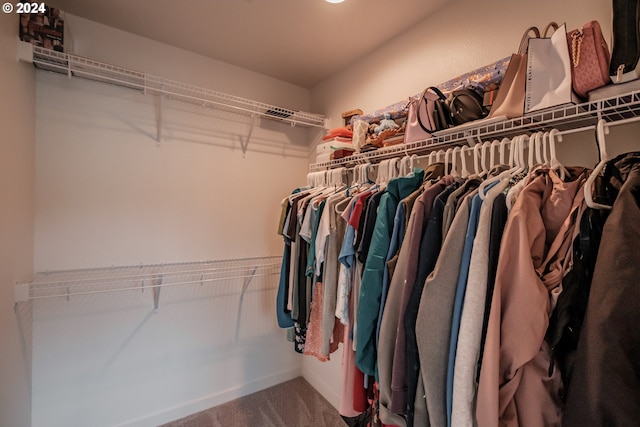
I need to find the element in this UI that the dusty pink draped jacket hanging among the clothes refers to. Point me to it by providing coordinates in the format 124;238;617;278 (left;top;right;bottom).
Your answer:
476;168;587;427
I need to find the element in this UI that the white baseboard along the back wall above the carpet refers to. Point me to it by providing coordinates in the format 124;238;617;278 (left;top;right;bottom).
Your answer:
117;367;302;427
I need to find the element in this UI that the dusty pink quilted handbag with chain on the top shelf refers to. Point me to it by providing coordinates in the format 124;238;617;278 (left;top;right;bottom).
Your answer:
567;21;611;98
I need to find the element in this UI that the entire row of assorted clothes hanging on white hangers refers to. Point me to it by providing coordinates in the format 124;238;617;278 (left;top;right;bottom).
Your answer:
277;148;640;427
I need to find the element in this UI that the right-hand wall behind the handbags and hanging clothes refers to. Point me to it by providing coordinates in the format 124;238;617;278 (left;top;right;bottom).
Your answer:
303;0;619;412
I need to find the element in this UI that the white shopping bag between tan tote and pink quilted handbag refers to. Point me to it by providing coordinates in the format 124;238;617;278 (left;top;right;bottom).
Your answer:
524;23;577;113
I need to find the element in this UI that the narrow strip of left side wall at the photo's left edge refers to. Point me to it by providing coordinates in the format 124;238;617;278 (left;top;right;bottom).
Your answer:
0;13;35;427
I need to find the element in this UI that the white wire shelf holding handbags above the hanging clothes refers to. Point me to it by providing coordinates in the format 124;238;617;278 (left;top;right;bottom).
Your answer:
309;91;640;172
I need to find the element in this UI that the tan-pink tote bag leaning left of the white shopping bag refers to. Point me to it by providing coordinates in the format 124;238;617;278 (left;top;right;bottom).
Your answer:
488;27;540;119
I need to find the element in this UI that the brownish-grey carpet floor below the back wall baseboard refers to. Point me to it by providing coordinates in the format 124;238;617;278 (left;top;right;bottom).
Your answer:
161;377;346;427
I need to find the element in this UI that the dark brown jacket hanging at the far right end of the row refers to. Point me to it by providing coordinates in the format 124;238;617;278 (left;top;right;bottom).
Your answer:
564;152;640;427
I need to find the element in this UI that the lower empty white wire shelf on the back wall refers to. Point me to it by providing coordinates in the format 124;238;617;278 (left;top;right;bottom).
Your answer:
14;256;282;309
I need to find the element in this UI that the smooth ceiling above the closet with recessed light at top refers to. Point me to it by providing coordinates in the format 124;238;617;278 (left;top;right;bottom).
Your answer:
47;0;452;88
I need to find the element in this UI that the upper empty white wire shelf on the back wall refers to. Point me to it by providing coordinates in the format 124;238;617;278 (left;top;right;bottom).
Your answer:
18;42;327;128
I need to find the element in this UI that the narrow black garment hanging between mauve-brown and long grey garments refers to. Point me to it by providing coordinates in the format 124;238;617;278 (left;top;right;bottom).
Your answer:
402;182;461;427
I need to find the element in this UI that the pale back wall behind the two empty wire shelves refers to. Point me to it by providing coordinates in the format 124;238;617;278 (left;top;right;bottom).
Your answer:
32;17;318;427
